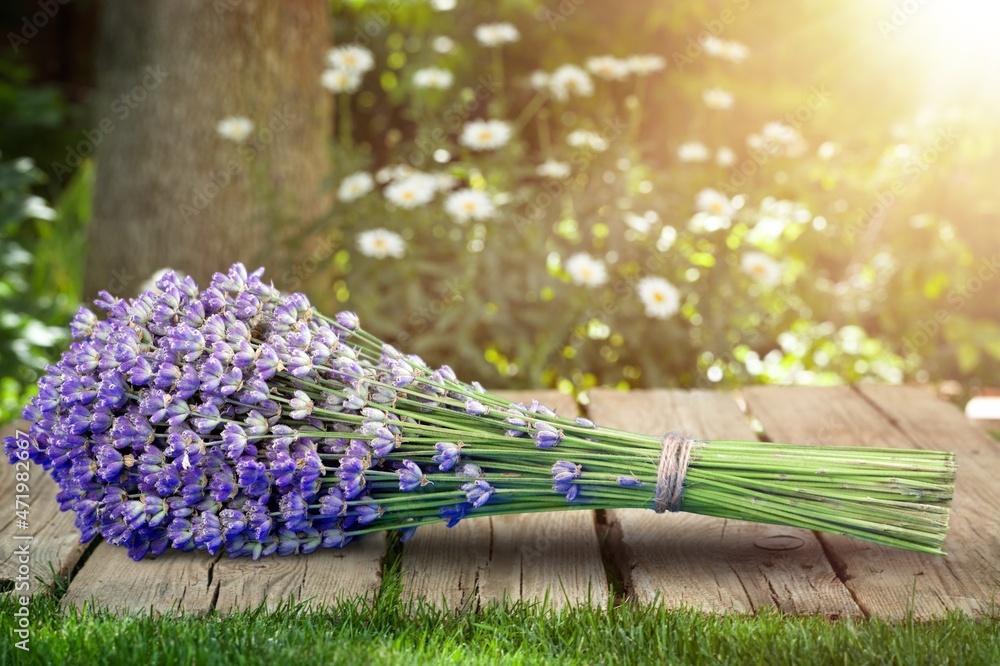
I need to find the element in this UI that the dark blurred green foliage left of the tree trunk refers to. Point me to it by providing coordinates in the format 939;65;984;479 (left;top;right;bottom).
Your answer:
0;54;93;423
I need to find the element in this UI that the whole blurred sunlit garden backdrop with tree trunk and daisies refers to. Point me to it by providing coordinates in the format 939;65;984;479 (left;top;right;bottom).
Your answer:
0;0;1000;420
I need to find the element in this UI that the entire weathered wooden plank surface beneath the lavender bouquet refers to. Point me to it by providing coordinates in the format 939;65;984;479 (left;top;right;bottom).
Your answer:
0;386;1000;619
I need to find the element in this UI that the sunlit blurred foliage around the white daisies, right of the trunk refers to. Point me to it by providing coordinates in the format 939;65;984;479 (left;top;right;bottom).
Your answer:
304;0;1000;391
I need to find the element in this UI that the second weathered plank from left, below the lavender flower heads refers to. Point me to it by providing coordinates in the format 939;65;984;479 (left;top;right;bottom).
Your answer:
62;543;218;614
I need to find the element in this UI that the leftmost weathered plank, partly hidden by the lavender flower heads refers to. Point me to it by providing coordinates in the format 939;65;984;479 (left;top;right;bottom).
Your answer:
0;423;87;596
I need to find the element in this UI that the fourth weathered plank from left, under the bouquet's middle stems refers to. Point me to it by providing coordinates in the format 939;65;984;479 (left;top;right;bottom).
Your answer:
402;391;608;609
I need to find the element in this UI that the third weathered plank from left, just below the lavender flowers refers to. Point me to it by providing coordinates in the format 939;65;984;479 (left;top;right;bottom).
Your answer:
212;532;386;613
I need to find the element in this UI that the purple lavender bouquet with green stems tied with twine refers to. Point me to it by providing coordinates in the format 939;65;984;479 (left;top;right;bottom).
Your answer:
4;264;955;560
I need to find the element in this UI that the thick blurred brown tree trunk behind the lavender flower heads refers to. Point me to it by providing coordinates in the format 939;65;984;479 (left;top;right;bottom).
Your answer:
84;0;331;298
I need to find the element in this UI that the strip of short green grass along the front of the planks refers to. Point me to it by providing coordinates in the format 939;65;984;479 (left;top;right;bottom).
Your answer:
0;564;1000;666
